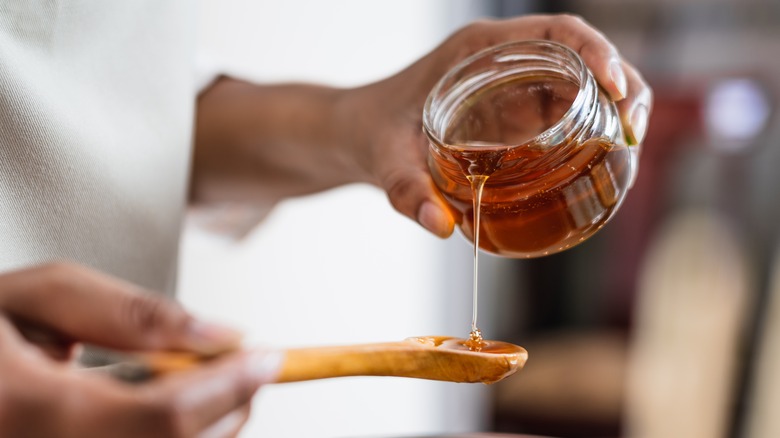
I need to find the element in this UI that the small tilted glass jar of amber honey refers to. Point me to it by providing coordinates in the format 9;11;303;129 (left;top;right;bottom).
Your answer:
423;41;638;258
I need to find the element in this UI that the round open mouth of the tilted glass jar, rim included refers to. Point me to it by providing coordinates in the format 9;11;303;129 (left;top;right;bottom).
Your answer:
423;40;595;150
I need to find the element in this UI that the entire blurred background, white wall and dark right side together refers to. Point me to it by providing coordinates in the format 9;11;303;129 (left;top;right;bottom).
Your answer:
180;0;780;438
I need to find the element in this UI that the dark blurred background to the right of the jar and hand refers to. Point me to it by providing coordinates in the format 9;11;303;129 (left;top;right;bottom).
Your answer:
490;0;780;438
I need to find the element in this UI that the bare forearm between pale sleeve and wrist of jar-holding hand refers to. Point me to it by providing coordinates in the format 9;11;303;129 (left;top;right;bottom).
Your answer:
191;78;369;203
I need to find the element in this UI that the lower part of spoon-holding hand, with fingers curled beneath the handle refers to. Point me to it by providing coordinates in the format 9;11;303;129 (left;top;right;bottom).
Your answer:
0;346;266;438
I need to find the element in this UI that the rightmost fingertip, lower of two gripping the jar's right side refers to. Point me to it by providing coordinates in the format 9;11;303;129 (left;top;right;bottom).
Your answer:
617;62;653;145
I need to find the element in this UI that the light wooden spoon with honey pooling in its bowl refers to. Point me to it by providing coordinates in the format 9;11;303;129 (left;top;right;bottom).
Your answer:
119;336;528;383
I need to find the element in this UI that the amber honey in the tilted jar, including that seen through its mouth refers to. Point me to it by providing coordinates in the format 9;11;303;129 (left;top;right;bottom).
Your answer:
429;77;635;258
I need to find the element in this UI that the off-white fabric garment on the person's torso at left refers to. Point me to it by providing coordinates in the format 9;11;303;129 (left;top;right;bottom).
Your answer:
0;0;196;293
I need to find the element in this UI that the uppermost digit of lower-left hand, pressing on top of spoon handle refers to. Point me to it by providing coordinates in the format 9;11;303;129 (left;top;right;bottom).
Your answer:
0;263;240;354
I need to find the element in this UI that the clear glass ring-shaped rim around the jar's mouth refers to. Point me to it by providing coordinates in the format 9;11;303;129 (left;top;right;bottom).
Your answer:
423;39;592;150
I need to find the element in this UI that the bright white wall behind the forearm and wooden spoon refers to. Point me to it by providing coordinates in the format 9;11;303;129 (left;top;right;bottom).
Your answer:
179;0;485;438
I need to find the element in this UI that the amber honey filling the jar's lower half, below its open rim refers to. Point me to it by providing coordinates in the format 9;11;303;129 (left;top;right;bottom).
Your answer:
431;135;631;257
